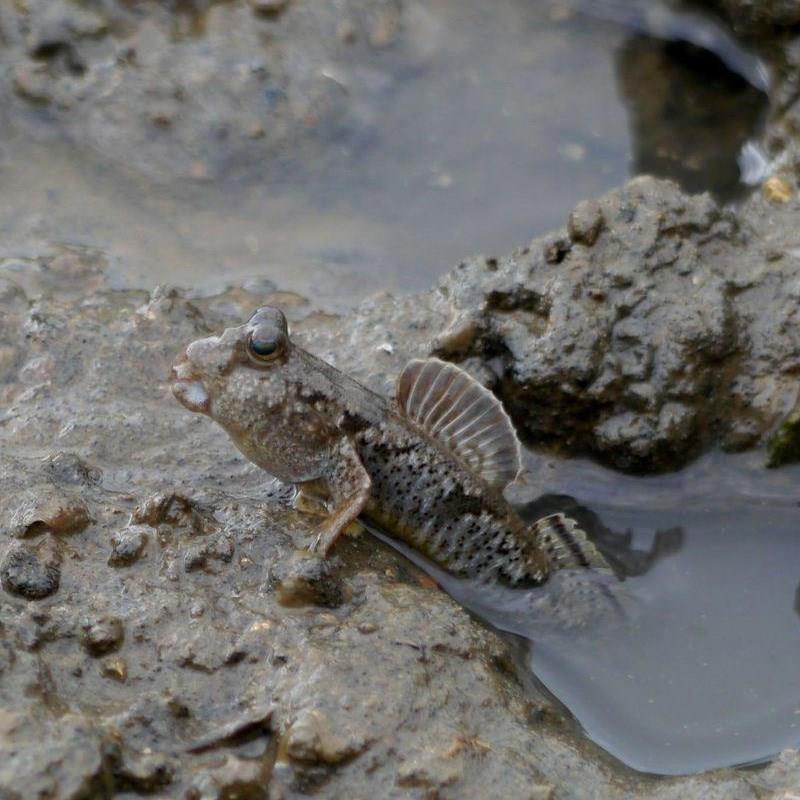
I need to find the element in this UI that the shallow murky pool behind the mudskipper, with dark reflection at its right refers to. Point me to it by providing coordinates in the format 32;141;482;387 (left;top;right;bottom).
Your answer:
0;0;764;308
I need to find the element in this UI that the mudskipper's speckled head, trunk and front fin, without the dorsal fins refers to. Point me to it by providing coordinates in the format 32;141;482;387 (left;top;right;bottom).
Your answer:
173;308;549;586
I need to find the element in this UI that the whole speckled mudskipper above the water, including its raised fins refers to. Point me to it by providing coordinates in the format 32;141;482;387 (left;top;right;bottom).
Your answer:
173;308;605;586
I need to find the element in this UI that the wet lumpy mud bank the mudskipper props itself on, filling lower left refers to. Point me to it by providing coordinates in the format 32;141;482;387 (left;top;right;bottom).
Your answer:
0;253;800;798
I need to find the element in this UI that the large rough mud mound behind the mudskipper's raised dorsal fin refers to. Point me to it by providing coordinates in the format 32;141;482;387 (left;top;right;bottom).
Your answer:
296;178;800;471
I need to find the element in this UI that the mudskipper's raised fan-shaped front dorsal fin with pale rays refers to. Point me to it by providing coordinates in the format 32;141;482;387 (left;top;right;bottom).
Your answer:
397;358;521;488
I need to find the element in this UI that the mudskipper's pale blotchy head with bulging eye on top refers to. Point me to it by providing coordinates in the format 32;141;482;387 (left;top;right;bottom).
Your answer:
172;306;292;439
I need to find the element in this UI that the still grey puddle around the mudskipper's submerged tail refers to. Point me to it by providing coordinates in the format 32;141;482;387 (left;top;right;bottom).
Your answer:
372;454;800;774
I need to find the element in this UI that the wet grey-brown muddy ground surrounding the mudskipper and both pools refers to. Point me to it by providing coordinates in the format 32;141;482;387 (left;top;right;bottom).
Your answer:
0;2;800;798
